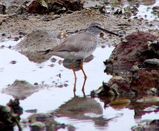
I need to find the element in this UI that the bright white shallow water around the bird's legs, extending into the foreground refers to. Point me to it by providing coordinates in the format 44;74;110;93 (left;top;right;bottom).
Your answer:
0;38;159;131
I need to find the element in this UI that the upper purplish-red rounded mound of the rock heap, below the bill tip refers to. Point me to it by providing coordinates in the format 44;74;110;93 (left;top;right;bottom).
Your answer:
106;32;157;73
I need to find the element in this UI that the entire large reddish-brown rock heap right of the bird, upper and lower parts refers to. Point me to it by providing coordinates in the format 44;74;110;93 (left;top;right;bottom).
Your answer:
93;32;159;98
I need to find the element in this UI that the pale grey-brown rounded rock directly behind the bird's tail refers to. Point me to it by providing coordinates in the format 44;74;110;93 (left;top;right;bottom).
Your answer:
14;30;58;63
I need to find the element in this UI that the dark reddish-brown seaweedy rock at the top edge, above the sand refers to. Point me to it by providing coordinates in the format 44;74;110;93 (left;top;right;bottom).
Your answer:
28;0;83;14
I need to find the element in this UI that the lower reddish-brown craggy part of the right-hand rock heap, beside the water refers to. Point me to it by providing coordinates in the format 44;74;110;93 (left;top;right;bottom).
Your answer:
97;69;159;98
